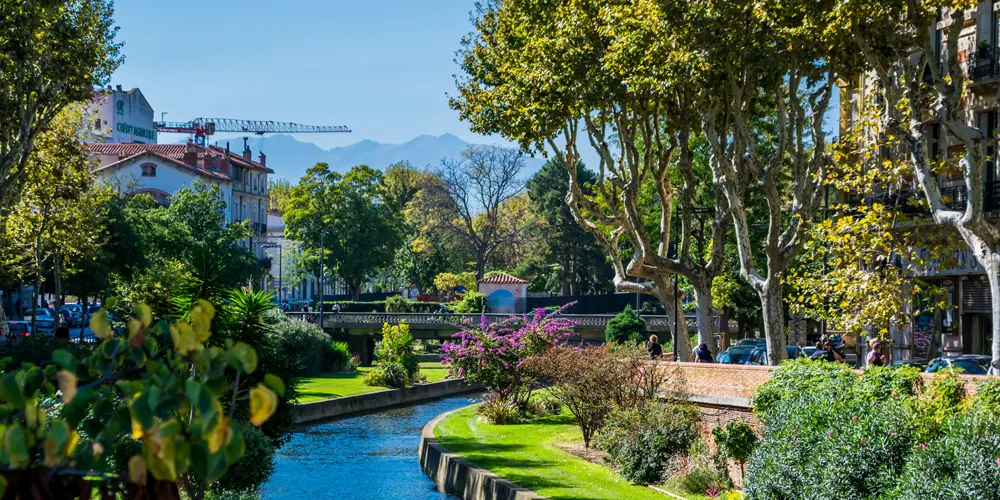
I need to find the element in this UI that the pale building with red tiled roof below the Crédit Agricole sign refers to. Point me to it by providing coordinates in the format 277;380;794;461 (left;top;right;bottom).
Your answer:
87;141;274;256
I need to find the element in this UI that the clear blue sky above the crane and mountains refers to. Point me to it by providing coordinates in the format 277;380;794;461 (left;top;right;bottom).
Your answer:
112;0;484;148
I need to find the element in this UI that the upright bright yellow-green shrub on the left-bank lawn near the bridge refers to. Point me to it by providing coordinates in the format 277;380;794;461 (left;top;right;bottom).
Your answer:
364;323;420;389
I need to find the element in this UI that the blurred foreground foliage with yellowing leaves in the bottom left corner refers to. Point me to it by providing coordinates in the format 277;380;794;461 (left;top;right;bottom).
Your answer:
0;301;284;498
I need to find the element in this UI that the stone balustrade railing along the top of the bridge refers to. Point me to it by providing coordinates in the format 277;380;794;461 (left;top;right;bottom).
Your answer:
286;312;673;332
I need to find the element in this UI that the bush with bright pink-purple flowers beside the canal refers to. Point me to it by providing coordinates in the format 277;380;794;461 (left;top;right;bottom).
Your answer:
441;309;576;405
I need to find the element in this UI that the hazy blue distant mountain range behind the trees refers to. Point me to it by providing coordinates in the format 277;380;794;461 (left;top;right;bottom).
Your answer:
205;134;545;183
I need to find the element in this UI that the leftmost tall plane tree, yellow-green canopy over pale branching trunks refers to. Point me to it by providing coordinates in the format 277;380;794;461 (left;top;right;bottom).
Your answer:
451;0;744;359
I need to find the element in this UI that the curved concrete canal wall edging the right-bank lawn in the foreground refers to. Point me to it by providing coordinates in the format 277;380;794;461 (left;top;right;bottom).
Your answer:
420;410;545;500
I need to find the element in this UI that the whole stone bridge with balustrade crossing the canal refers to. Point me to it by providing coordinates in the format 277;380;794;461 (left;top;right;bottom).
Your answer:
286;312;673;364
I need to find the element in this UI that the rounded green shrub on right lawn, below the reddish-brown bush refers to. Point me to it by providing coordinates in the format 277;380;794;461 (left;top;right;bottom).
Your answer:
595;402;698;484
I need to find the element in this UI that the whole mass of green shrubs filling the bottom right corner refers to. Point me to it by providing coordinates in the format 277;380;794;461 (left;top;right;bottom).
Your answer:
745;361;1000;499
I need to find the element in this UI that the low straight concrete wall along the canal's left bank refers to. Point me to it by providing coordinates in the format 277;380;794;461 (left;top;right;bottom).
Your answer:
292;379;478;424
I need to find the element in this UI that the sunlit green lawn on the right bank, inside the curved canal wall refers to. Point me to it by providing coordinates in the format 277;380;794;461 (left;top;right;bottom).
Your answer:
434;407;669;500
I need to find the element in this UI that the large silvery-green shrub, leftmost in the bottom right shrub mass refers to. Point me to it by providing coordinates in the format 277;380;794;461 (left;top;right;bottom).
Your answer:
744;361;913;500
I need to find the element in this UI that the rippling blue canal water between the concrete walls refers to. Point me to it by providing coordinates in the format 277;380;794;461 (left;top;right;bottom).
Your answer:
262;396;475;500
